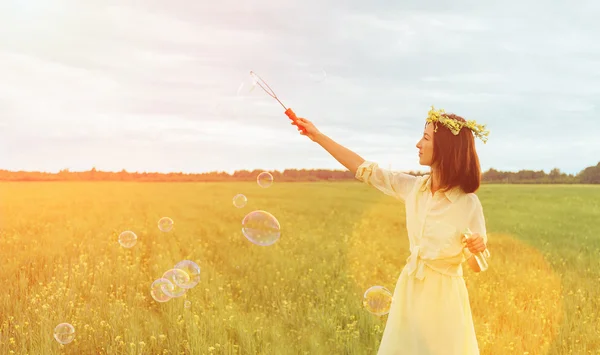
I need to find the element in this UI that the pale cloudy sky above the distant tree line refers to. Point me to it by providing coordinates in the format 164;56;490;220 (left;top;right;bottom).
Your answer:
0;0;600;174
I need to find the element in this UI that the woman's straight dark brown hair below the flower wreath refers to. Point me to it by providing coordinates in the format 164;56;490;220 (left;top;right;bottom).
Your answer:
432;113;481;193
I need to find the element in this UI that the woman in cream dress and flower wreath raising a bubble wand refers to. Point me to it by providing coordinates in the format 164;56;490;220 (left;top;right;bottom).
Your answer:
292;107;489;355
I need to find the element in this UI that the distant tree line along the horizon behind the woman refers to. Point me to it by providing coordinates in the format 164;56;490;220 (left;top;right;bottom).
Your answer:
0;162;600;184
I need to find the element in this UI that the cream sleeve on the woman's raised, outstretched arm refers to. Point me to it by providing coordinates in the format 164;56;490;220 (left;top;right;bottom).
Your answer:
355;161;417;202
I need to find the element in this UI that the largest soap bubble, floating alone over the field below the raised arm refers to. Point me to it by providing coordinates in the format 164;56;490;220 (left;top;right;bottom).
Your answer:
242;210;281;246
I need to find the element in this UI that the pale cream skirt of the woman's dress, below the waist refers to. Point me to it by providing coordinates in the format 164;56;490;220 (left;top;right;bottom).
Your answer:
377;265;479;355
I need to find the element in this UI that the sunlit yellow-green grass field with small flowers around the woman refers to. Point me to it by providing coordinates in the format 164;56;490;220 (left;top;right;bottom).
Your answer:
0;182;600;355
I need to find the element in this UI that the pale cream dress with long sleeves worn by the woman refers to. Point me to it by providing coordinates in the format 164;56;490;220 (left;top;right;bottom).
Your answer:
356;161;487;355
